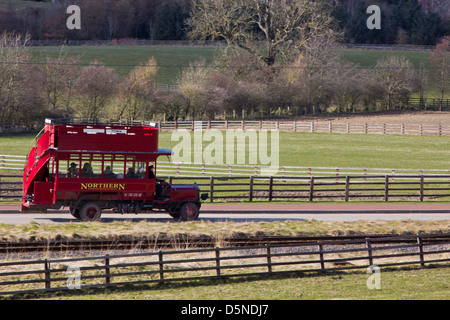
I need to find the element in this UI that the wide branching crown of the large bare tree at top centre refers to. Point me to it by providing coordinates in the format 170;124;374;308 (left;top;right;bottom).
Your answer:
187;0;334;66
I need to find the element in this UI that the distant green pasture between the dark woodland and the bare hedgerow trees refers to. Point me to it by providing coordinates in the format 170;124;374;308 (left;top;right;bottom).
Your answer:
30;46;437;95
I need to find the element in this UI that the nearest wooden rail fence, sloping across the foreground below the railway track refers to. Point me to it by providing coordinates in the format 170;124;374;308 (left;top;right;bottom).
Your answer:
0;234;450;295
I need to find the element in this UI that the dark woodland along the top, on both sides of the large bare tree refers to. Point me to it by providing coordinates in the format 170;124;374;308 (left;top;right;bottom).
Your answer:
0;0;450;45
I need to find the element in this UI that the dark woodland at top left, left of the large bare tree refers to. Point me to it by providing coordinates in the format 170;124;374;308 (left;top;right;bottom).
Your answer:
0;0;190;40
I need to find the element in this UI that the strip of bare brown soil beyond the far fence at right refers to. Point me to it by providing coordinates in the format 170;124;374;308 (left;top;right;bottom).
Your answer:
296;111;450;125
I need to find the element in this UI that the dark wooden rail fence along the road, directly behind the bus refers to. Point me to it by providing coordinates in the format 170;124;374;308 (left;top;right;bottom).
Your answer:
0;175;450;202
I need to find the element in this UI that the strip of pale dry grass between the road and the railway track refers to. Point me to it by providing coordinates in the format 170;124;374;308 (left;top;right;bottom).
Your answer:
0;219;450;243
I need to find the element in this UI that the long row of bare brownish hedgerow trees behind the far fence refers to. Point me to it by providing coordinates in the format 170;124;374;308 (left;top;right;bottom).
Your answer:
0;33;450;122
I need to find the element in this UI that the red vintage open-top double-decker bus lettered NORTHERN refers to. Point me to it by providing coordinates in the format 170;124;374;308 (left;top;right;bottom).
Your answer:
22;119;208;221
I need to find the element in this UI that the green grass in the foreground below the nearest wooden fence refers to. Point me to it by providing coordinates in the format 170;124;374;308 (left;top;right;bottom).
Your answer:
22;268;449;302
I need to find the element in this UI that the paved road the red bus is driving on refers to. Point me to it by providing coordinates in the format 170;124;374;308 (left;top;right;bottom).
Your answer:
0;204;450;224
